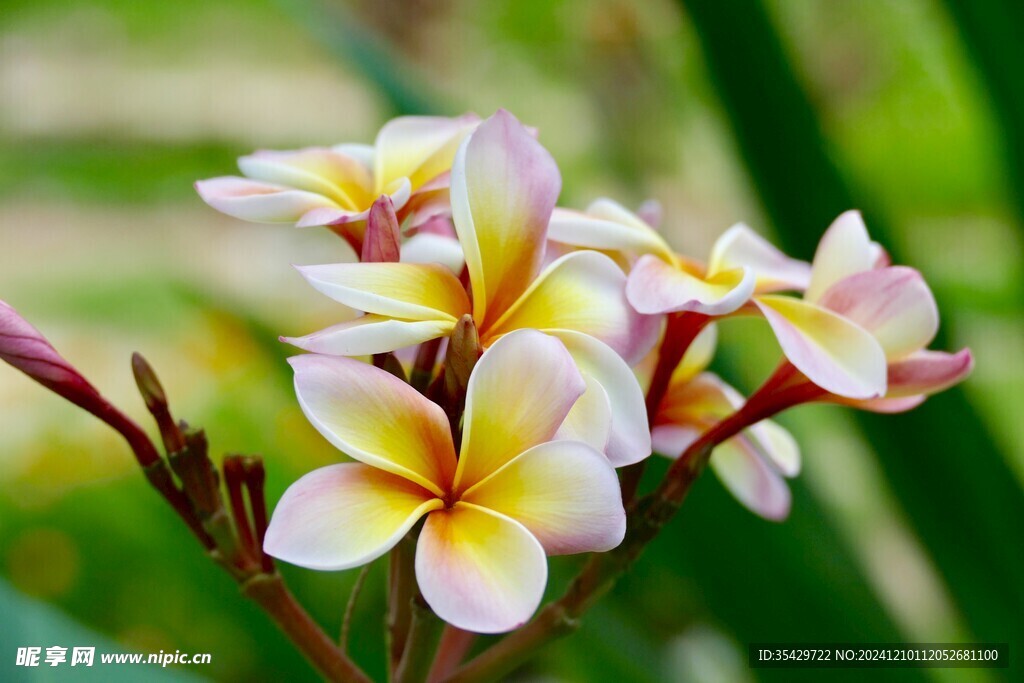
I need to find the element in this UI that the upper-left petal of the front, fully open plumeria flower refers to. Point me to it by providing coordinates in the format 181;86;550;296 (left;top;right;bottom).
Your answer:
289;355;456;496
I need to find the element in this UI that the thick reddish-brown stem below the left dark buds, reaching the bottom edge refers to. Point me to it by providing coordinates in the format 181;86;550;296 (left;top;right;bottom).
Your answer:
242;573;370;683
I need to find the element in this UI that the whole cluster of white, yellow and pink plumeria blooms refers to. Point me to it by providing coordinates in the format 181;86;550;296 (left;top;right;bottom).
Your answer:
197;111;972;633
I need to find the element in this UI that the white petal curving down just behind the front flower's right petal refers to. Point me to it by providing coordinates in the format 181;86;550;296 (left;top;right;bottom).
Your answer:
555;331;651;467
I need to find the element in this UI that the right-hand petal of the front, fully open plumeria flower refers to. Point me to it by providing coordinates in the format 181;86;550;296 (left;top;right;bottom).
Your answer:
462;441;626;555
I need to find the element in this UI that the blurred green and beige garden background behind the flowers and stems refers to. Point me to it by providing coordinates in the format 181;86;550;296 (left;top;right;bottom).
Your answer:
0;0;1024;683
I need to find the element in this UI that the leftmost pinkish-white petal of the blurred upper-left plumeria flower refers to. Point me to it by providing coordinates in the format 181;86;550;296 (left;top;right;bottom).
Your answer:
196;177;337;223
